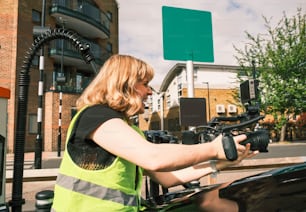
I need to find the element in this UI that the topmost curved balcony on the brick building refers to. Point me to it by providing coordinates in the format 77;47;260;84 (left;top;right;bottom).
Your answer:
49;0;110;39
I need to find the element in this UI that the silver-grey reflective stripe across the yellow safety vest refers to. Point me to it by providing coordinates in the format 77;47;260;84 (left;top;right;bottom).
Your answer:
56;174;138;207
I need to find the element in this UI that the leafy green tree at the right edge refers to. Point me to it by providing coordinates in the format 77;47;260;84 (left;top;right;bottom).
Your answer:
234;9;306;140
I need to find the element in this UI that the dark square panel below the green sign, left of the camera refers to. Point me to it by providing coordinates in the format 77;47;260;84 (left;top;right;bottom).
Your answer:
180;98;207;126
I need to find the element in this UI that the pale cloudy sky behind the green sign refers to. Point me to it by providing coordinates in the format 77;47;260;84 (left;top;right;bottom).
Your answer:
117;0;306;89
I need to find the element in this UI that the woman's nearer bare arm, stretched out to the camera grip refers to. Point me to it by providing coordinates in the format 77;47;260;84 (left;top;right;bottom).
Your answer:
90;118;250;171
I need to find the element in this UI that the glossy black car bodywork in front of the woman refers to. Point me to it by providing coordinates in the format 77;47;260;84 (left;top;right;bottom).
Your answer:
145;163;306;212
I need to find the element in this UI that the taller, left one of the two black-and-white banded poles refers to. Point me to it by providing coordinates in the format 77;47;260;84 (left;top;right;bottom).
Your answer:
34;0;46;169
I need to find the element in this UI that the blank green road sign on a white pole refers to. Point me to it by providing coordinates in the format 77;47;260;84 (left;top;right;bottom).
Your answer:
162;6;214;62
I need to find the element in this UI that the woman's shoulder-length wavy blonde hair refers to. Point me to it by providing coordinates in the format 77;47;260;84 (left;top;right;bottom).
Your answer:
76;55;154;118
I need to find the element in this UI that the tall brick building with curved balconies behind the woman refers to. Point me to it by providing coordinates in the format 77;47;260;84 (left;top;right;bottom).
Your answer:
0;0;118;152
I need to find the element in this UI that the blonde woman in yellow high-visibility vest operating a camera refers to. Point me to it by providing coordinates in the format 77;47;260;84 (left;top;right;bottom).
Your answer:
52;55;255;212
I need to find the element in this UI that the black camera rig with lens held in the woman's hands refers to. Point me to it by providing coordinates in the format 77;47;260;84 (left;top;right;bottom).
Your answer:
182;79;270;161
